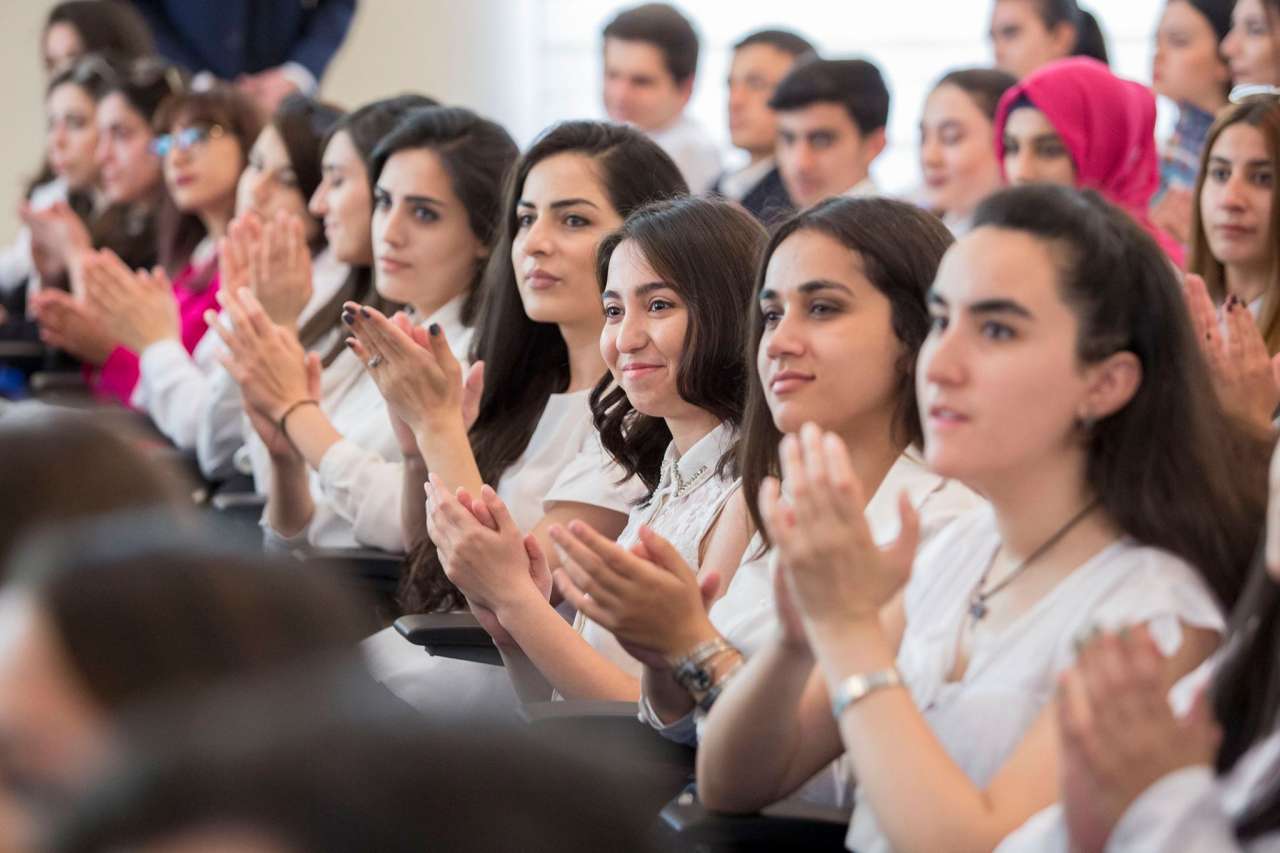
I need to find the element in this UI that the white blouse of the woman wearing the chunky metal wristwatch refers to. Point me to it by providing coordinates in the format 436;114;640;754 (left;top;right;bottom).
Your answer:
640;451;982;747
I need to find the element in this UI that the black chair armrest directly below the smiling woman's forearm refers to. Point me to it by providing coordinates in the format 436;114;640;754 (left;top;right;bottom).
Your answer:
520;699;695;768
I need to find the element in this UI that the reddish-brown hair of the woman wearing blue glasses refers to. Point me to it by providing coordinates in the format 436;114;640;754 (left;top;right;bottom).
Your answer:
152;83;262;289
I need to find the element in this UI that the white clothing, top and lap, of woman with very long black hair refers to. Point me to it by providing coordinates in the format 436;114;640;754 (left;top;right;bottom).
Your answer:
362;381;644;713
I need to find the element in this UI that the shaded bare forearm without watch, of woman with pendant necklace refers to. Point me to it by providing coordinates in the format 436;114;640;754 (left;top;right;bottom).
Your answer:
698;642;840;812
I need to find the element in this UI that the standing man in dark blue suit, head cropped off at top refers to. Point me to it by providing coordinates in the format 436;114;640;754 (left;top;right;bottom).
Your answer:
133;0;356;111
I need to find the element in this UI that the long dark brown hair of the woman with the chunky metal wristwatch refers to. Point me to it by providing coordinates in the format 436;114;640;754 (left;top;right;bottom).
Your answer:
740;199;955;546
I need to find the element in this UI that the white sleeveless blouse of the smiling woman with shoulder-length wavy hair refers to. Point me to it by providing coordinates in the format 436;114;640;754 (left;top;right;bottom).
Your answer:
573;424;741;679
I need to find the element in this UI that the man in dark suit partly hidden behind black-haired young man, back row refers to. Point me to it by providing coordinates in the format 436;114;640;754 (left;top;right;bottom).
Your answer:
712;29;815;224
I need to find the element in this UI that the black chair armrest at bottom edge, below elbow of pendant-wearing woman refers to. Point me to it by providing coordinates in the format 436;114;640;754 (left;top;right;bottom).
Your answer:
660;790;849;853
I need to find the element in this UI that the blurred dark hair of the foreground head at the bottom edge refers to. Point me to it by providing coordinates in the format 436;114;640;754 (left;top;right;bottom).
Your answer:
41;666;660;853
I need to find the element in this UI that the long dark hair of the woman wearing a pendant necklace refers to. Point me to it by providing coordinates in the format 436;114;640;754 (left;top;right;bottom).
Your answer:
974;186;1270;608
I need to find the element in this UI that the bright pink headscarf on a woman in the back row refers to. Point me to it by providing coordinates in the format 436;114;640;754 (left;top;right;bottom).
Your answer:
996;56;1183;266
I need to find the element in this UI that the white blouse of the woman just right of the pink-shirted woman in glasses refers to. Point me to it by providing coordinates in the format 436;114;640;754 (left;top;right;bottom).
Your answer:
129;243;347;450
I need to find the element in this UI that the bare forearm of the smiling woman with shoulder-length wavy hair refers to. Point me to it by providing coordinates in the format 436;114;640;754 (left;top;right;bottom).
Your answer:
498;597;640;702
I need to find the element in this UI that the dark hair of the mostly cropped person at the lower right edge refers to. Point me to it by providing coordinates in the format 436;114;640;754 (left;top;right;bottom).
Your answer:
1211;547;1280;839
